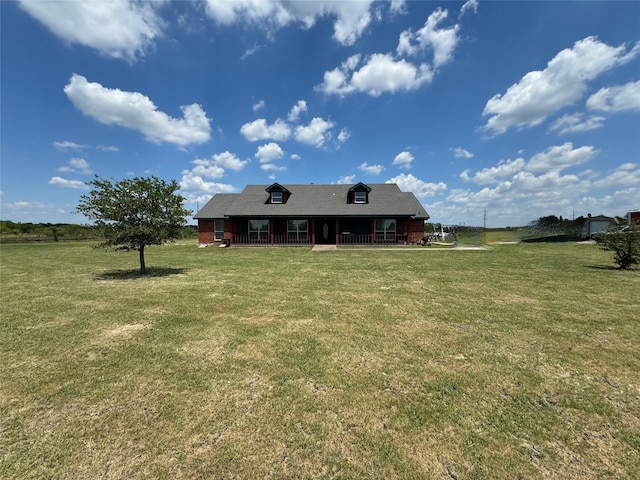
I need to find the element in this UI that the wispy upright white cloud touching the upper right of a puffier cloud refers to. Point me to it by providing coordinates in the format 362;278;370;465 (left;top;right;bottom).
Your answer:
396;8;460;69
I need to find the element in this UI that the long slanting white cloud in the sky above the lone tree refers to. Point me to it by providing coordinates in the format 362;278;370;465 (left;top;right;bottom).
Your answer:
64;74;211;146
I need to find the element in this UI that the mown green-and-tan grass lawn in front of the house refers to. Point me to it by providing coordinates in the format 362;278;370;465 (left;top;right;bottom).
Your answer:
0;243;640;480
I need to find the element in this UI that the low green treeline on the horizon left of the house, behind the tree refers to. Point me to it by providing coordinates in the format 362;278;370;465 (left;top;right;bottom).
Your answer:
0;220;198;243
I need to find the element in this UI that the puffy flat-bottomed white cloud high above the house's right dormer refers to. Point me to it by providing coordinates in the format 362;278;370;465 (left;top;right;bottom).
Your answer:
316;53;433;97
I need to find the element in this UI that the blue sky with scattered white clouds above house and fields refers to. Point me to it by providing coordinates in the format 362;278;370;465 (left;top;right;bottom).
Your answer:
0;0;640;227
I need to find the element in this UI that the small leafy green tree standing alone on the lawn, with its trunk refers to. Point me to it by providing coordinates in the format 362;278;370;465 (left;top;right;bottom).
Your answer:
77;176;191;274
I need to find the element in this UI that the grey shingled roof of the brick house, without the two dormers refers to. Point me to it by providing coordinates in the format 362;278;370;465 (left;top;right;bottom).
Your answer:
194;183;429;220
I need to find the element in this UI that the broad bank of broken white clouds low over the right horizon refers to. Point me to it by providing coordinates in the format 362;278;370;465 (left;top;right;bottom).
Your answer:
438;143;640;225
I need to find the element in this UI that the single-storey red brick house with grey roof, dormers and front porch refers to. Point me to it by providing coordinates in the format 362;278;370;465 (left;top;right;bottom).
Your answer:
194;183;429;245
